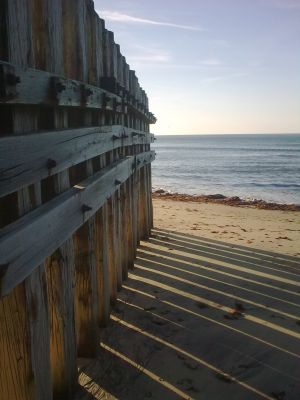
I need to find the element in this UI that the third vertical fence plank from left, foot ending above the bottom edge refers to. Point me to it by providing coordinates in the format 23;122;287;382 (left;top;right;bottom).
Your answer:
71;7;102;357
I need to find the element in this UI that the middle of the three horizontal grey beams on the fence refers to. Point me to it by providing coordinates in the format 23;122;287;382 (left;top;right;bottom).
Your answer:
0;125;154;197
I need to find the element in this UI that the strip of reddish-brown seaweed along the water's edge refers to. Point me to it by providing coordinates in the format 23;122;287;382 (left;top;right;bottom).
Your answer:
152;189;300;212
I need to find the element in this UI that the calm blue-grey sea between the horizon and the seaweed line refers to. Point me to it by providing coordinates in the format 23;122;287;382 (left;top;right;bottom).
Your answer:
152;134;300;205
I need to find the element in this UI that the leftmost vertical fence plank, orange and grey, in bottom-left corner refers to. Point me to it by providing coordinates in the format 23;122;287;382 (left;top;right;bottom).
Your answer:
0;0;52;400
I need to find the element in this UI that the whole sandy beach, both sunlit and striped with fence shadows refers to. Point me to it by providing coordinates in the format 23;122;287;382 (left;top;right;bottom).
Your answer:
76;199;300;400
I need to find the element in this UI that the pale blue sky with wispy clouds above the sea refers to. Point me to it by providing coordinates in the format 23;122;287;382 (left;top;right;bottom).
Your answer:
94;0;300;134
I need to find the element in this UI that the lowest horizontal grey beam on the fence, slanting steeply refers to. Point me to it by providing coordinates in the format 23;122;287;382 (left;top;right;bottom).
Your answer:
0;151;155;297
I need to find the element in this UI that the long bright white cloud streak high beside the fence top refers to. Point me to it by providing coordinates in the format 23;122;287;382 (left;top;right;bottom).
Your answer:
97;10;205;31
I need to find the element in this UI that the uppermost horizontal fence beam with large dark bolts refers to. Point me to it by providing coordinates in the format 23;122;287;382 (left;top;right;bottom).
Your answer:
0;60;156;123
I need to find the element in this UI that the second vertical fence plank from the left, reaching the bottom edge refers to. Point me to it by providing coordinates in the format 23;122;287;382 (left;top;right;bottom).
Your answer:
43;0;77;399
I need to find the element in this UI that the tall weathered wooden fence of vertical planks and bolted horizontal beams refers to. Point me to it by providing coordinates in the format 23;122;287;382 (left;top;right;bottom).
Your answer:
0;0;155;400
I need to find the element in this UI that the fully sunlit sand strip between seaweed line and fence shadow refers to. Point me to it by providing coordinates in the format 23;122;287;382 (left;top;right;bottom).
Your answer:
153;199;300;256
